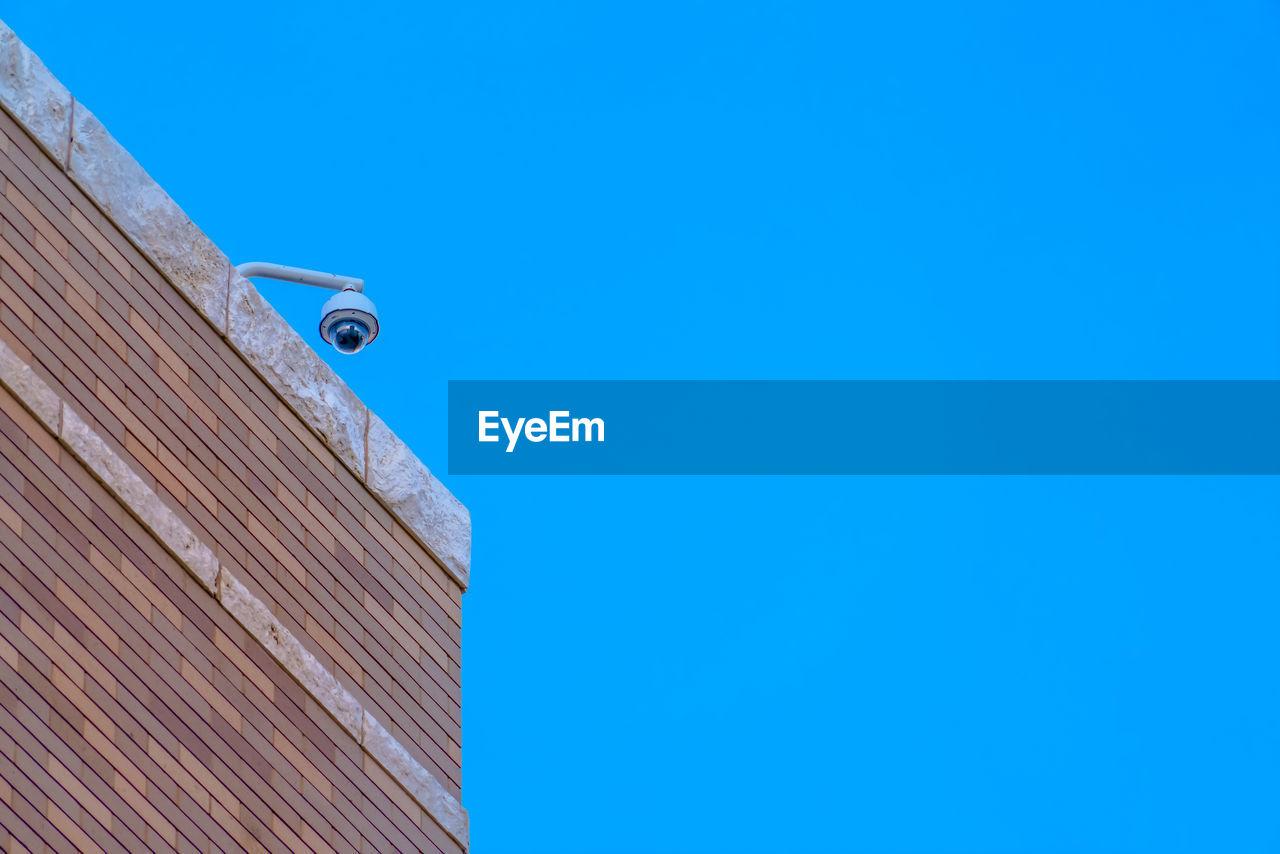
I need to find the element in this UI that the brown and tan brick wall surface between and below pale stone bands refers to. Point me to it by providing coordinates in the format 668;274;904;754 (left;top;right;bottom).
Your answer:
0;53;462;851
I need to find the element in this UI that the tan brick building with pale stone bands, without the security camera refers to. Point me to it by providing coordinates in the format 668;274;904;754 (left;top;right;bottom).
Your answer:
0;24;471;851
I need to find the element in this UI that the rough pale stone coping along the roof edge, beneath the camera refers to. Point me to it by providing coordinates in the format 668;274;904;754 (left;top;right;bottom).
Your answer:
0;22;471;590
